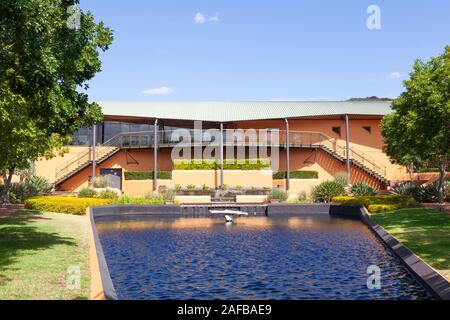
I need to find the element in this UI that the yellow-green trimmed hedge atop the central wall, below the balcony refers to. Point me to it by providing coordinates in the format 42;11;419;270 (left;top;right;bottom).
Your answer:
173;159;270;170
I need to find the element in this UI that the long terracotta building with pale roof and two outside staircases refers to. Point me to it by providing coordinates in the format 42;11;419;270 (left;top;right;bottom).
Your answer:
36;101;406;195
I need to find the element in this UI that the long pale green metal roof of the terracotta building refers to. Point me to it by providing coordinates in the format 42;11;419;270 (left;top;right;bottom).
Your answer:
99;101;391;122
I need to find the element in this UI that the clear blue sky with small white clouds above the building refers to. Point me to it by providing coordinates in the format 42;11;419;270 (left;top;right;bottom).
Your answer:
80;0;450;101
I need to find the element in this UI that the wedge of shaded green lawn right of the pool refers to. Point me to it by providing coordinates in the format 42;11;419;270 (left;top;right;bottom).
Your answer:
372;208;450;281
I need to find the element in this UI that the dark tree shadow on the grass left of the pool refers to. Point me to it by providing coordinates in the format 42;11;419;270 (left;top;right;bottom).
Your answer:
0;210;76;285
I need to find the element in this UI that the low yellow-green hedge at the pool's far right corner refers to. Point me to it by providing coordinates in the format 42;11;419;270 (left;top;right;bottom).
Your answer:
333;195;416;213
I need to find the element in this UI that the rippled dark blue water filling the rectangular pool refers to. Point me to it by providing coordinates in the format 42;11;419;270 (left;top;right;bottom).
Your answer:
97;215;429;299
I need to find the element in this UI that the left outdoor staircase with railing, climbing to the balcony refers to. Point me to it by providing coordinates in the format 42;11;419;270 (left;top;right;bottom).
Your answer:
55;146;120;186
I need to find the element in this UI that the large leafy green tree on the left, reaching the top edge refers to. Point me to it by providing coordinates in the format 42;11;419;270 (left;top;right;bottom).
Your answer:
0;0;113;204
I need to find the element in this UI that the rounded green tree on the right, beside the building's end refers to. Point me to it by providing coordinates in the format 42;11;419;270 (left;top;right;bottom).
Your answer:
381;46;450;202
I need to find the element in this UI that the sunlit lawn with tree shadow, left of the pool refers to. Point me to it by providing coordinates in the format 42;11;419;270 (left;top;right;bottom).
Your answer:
0;210;89;299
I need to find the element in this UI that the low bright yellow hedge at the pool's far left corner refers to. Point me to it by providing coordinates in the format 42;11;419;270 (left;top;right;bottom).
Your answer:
25;196;112;215
